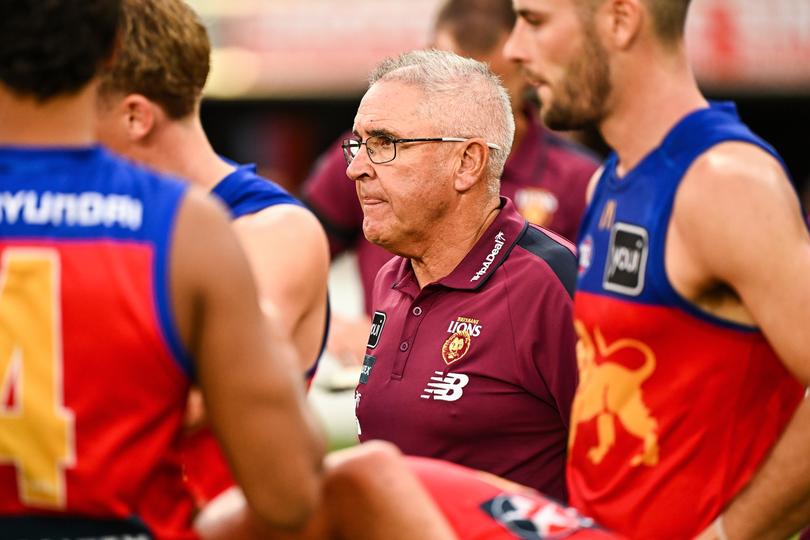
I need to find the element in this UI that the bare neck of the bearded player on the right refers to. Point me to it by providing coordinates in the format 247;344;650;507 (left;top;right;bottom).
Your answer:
600;47;708;175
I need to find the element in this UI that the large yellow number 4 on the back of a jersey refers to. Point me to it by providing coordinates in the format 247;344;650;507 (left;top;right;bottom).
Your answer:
0;248;75;508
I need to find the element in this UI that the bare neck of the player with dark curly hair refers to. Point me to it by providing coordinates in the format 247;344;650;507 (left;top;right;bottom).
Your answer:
0;83;96;147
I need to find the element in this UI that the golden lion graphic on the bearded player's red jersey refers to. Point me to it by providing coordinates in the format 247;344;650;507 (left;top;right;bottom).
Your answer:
568;321;658;467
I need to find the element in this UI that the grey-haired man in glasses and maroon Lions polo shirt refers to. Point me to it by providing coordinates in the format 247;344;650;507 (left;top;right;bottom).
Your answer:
350;51;577;500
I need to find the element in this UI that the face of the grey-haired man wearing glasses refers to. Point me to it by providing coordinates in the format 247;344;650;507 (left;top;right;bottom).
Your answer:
346;82;454;257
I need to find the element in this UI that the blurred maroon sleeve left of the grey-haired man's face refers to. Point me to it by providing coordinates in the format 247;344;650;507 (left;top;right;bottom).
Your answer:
301;133;363;257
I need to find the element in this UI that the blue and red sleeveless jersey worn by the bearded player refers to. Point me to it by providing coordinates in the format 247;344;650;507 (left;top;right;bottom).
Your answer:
568;103;803;538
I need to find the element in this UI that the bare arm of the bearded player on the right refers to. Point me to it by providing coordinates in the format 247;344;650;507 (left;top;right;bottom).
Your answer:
667;143;810;540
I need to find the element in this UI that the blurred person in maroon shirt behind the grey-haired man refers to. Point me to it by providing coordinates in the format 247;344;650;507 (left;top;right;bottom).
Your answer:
303;0;598;372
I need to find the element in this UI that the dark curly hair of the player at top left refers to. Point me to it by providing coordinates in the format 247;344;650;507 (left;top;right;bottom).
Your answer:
0;0;121;102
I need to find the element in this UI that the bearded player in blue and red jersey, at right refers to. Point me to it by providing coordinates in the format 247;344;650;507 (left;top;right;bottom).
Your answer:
505;0;810;540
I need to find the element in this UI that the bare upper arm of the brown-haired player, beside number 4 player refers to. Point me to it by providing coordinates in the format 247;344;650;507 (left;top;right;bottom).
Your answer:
234;204;329;371
